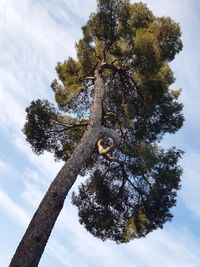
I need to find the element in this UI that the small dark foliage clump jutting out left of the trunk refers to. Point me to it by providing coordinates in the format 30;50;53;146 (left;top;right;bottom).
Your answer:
23;100;87;160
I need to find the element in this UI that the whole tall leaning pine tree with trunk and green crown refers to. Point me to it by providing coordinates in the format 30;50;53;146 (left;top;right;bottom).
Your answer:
10;0;184;267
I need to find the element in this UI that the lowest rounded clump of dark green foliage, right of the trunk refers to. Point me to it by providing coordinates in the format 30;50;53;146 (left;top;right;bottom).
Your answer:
73;146;181;243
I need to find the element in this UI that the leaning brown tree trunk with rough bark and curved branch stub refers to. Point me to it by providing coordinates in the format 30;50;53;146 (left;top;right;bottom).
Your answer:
9;70;120;267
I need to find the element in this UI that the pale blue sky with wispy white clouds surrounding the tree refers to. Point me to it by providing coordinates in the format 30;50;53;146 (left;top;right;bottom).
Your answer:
0;0;200;267
